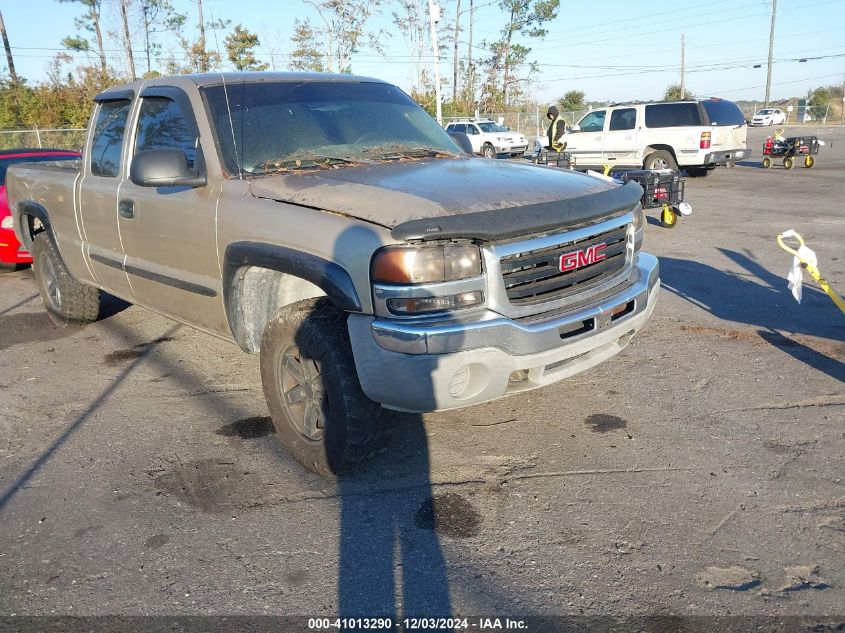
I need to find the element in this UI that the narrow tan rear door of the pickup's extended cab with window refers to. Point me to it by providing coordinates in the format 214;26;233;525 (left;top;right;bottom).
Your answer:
79;92;134;301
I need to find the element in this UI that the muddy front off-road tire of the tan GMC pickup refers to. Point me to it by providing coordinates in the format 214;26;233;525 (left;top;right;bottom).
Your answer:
261;298;389;478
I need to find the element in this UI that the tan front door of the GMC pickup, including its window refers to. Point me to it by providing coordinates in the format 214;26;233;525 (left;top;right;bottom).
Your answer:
118;86;228;333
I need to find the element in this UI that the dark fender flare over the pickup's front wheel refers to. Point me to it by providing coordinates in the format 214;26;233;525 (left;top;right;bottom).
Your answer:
223;242;362;348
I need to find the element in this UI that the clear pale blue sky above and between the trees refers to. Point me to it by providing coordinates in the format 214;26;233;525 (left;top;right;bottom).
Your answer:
0;0;845;103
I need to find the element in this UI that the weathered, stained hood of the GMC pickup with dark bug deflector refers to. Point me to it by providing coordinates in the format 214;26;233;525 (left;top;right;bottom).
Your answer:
251;158;642;239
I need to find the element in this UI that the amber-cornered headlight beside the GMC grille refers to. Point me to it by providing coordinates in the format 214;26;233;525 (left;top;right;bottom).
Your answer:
372;244;481;285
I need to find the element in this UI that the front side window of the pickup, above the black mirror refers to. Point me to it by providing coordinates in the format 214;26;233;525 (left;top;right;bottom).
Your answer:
135;97;197;167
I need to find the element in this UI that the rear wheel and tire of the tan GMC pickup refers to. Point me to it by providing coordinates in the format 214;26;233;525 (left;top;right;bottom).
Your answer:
32;231;100;327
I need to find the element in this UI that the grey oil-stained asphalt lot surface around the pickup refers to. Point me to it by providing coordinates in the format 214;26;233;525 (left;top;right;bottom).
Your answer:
0;127;845;630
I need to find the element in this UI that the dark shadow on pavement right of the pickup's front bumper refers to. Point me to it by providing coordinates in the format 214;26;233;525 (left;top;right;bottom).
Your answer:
660;249;845;380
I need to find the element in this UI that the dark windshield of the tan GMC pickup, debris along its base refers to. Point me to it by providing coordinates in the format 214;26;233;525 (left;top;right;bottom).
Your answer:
203;81;462;175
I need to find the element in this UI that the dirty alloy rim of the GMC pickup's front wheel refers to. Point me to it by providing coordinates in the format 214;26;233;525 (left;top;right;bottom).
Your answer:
278;345;325;442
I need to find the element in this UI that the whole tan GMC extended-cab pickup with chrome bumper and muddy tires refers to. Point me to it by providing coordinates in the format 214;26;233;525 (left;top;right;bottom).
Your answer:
8;73;660;475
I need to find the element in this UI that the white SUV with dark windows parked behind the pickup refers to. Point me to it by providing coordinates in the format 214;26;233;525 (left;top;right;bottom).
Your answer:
535;99;751;176
